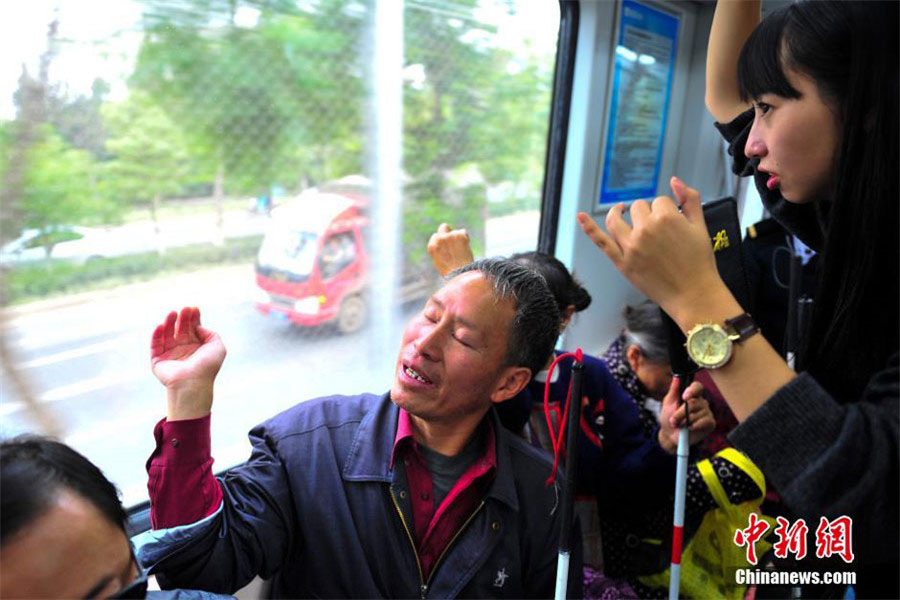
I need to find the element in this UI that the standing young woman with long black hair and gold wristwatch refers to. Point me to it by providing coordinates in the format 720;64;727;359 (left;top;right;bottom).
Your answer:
578;0;900;597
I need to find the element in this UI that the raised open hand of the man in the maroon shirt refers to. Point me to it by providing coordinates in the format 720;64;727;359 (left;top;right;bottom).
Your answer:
150;307;225;421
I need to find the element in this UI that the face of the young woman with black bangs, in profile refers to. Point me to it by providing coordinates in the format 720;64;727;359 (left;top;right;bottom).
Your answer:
744;69;840;204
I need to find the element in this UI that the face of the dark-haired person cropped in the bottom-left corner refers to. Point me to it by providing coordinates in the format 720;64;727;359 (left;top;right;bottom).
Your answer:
0;491;138;598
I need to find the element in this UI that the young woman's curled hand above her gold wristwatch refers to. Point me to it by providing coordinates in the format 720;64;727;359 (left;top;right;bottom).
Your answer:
578;177;727;329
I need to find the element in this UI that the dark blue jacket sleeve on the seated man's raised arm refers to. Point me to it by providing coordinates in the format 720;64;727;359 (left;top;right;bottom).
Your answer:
135;425;298;594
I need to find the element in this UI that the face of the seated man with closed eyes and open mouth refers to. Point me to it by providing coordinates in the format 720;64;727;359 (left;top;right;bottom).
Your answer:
391;271;527;424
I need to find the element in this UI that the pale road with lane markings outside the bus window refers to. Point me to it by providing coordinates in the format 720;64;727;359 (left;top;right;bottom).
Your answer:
0;265;417;506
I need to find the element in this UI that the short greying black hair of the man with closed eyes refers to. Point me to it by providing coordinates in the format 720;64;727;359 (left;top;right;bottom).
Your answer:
447;258;560;376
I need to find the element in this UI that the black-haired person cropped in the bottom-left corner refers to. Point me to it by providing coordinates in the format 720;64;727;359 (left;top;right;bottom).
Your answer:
0;435;231;600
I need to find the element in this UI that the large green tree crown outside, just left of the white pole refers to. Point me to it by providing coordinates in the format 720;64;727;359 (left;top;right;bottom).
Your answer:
132;0;364;240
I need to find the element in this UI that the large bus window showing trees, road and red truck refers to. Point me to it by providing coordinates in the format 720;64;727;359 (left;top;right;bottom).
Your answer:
0;0;560;506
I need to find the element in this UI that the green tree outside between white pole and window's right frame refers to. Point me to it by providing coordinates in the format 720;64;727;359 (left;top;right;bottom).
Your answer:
404;0;553;256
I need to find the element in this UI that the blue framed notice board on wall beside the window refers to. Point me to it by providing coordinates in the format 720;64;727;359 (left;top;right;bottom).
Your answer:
598;0;680;208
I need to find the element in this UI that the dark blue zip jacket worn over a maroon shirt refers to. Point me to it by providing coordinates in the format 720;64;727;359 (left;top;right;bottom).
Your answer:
139;394;582;598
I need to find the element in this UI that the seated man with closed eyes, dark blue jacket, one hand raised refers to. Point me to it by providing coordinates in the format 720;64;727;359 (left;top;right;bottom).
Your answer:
139;259;581;598
